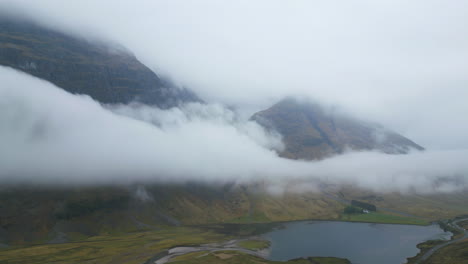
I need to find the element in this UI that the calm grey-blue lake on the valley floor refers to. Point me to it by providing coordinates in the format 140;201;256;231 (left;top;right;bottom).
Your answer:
263;221;451;264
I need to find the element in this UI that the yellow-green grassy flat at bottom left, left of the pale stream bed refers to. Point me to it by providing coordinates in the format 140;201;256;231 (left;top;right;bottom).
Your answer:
0;227;232;264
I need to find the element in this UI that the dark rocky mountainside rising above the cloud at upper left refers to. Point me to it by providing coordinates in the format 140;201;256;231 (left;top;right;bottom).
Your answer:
0;17;199;108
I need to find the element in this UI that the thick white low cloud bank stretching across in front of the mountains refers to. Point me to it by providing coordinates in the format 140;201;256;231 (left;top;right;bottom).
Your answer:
0;67;468;192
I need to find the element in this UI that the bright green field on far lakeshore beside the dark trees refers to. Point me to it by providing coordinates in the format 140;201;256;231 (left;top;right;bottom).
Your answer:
341;212;429;225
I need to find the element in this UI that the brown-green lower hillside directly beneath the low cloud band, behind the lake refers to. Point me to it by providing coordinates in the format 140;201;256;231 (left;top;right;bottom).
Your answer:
0;183;468;247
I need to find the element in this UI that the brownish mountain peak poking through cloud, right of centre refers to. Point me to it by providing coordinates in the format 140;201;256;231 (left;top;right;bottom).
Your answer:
252;98;424;160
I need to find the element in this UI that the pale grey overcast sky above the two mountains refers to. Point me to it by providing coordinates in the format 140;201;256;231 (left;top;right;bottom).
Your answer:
0;0;468;149
